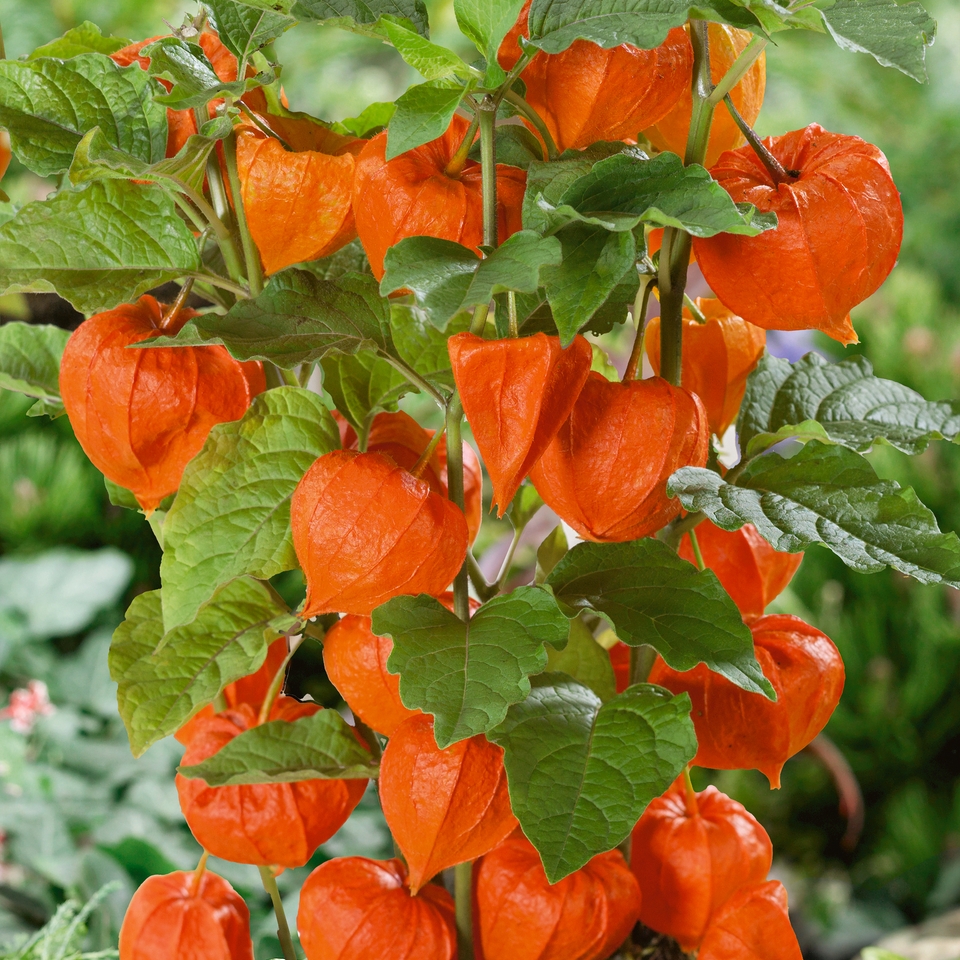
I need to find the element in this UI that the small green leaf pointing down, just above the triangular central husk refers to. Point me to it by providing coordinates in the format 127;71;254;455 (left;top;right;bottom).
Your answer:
543;223;639;347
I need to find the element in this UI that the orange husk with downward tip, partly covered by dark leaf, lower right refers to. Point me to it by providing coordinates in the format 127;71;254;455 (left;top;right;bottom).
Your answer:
650;615;844;789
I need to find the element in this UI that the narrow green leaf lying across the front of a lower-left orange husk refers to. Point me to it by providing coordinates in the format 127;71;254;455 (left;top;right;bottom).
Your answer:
177;710;379;787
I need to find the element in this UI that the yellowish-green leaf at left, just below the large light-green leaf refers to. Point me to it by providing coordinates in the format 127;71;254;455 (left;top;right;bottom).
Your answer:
110;578;284;757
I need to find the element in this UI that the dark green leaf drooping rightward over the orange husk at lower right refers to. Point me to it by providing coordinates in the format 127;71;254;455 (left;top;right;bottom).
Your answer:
546;538;776;700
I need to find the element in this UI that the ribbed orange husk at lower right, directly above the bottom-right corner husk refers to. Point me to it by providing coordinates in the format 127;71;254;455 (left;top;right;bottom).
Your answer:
630;781;773;952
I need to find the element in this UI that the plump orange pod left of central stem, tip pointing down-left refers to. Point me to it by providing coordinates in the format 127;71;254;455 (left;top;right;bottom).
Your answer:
290;450;468;617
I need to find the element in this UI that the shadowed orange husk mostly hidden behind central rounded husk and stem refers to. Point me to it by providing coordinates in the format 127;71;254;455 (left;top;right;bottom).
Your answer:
341;410;483;543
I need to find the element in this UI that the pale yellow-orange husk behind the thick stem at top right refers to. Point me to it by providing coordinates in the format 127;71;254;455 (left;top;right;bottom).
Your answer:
644;23;767;167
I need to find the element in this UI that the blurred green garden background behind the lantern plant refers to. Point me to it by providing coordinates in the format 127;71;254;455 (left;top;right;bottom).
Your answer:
0;0;960;960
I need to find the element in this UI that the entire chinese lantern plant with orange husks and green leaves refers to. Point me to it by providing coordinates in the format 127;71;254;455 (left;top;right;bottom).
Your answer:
0;0;960;960
